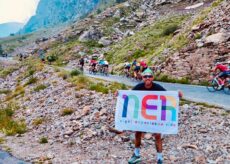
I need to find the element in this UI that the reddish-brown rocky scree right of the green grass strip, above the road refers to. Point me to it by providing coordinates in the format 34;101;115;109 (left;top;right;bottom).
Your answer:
162;1;230;83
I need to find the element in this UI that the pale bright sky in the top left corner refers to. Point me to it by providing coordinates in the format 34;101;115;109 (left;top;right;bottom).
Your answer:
0;0;39;24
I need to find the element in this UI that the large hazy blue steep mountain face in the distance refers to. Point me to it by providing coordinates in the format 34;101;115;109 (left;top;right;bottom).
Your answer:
21;0;99;33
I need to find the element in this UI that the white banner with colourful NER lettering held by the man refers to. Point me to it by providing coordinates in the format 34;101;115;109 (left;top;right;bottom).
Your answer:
115;90;179;134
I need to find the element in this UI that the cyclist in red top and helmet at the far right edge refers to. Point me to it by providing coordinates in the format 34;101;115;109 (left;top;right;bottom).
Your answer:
213;62;230;89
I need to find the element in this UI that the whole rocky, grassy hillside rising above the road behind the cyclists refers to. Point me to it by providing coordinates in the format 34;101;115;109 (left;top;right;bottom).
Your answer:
0;0;229;84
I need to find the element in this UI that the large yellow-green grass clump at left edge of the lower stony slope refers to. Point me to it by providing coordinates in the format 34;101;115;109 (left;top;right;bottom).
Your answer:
0;105;26;135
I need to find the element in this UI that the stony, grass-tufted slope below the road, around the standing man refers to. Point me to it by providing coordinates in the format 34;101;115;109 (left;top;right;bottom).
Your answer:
0;61;230;163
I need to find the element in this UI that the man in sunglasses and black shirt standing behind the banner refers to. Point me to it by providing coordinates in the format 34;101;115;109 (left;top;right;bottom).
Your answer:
128;68;182;164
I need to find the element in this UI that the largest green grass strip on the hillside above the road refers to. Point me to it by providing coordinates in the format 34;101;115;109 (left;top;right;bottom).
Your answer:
105;15;189;63
